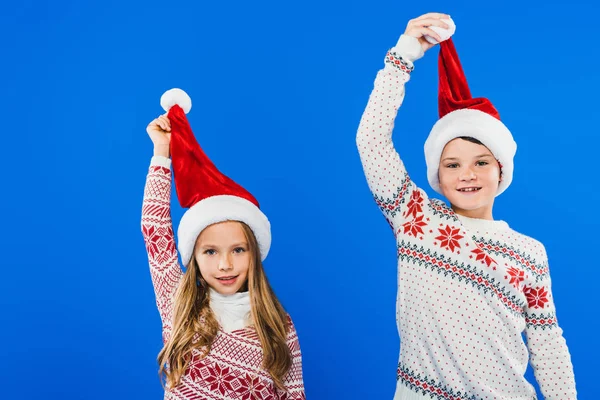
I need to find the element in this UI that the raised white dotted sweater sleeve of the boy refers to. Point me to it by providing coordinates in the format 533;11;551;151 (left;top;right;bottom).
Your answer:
356;36;425;232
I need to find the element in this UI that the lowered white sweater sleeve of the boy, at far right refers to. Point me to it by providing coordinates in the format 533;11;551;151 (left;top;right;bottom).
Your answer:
523;250;577;400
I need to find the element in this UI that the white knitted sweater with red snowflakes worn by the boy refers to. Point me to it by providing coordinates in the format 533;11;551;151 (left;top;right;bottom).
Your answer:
357;48;576;400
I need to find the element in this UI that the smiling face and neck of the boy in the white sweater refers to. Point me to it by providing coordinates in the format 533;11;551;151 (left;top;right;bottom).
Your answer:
438;139;501;219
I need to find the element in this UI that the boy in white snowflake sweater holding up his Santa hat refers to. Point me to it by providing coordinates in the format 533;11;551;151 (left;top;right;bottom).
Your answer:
357;13;576;400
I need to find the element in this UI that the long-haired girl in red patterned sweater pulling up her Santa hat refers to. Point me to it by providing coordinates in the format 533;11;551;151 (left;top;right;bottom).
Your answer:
142;89;305;400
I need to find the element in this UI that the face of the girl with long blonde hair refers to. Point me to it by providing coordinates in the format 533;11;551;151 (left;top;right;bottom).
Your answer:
194;221;253;295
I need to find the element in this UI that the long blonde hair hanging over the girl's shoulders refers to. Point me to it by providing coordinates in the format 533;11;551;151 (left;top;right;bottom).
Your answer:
158;222;292;389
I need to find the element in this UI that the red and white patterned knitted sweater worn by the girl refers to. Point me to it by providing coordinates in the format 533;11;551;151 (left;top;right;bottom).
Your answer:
142;157;305;400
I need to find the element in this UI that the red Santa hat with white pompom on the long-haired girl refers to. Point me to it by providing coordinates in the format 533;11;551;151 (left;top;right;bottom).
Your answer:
160;89;271;266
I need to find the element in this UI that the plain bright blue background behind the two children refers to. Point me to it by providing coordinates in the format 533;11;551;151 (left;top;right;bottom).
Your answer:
0;0;600;400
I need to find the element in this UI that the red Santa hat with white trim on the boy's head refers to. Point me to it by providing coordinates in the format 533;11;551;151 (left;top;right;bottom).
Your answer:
425;39;517;196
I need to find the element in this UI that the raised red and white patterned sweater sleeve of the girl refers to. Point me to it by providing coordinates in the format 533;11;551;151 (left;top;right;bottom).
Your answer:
142;156;183;341
